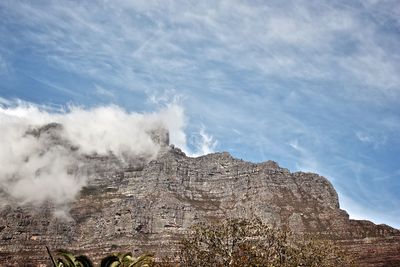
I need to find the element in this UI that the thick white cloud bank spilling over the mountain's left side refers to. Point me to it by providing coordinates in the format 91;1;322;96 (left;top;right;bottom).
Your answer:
0;102;216;210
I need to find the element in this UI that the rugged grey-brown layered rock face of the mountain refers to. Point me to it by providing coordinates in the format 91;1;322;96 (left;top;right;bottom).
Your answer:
0;147;400;266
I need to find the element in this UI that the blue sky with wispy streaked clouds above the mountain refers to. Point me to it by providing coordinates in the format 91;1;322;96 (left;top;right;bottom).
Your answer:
0;0;400;228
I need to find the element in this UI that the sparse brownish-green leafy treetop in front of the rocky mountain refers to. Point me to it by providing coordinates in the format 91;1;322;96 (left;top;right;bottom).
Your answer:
159;218;351;267
